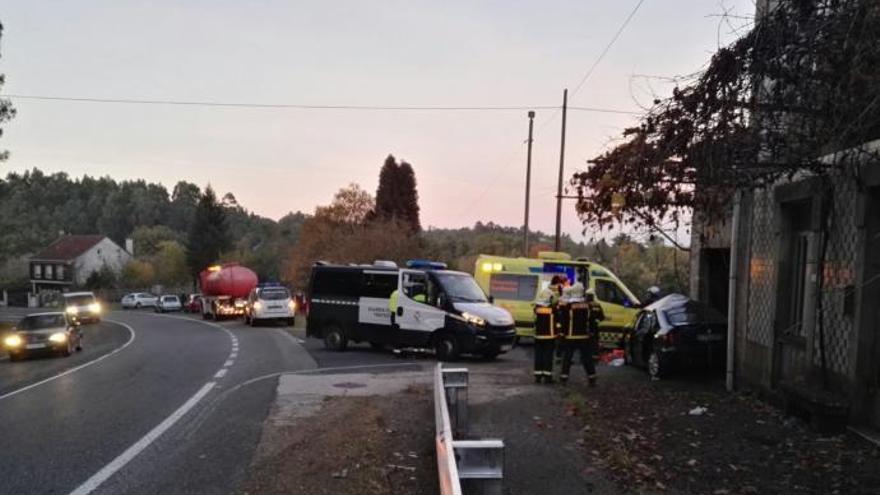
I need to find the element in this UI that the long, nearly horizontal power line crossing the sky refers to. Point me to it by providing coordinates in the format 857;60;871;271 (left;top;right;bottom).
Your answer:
0;94;634;114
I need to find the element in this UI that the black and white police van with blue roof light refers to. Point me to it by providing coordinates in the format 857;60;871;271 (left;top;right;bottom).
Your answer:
306;260;516;360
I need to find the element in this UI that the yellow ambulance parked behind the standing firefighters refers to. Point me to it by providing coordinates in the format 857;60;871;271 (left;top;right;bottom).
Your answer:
474;251;641;348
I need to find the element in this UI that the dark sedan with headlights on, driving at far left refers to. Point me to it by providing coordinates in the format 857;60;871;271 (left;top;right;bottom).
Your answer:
3;313;82;361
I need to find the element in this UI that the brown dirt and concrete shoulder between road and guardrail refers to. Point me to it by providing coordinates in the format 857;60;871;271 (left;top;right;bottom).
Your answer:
240;371;437;495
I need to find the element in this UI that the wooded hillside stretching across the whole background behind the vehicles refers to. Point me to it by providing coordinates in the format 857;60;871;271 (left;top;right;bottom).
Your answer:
0;159;687;294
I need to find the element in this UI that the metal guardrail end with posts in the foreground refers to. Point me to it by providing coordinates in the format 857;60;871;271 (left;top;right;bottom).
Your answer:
434;363;504;495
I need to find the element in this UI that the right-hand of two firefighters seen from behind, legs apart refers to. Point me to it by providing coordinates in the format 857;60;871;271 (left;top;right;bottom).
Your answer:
559;282;596;386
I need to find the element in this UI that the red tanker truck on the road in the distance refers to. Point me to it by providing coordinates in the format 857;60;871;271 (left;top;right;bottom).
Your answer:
199;263;257;320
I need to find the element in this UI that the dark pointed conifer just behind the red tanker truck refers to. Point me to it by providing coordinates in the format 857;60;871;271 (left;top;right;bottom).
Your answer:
187;185;229;277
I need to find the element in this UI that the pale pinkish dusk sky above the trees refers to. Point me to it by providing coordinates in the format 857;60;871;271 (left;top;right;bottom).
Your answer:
0;0;754;243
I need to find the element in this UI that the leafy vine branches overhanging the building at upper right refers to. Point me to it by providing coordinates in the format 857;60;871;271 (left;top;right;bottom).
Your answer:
571;0;880;231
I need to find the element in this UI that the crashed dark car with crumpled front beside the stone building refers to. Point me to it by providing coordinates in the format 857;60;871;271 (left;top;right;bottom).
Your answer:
624;294;727;379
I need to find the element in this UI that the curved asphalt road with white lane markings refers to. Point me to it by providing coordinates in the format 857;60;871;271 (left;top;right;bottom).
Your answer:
0;311;400;494
